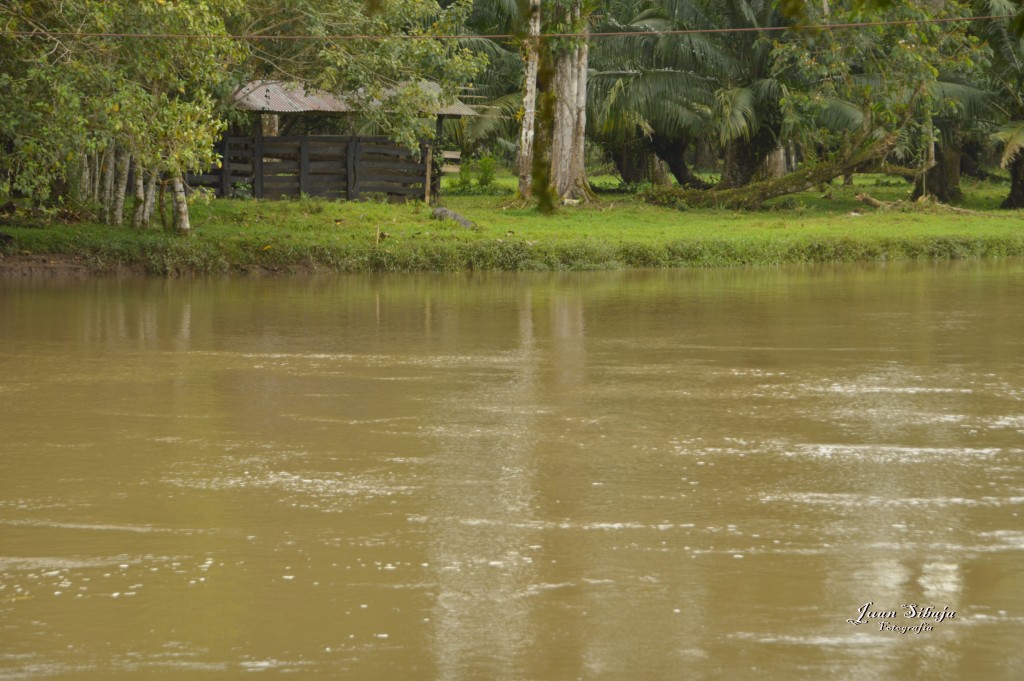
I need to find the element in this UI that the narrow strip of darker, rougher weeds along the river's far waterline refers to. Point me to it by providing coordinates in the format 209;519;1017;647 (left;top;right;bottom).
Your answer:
6;229;1024;279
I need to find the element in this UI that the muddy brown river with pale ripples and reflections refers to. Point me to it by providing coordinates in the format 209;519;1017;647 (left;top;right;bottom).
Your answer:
0;261;1024;681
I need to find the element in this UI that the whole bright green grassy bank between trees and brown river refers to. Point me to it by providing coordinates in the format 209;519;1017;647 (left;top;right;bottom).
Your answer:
0;177;1024;275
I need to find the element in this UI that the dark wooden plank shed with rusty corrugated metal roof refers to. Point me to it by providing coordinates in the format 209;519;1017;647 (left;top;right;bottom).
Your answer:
188;81;476;201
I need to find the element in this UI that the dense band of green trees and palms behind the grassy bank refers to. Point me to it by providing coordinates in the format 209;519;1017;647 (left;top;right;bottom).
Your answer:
0;0;1024;220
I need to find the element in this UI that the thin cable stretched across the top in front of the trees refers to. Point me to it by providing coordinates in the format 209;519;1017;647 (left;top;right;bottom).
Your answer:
0;14;1013;41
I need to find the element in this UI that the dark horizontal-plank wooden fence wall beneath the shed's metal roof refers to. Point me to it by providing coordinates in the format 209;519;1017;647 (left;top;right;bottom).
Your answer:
188;135;427;201
